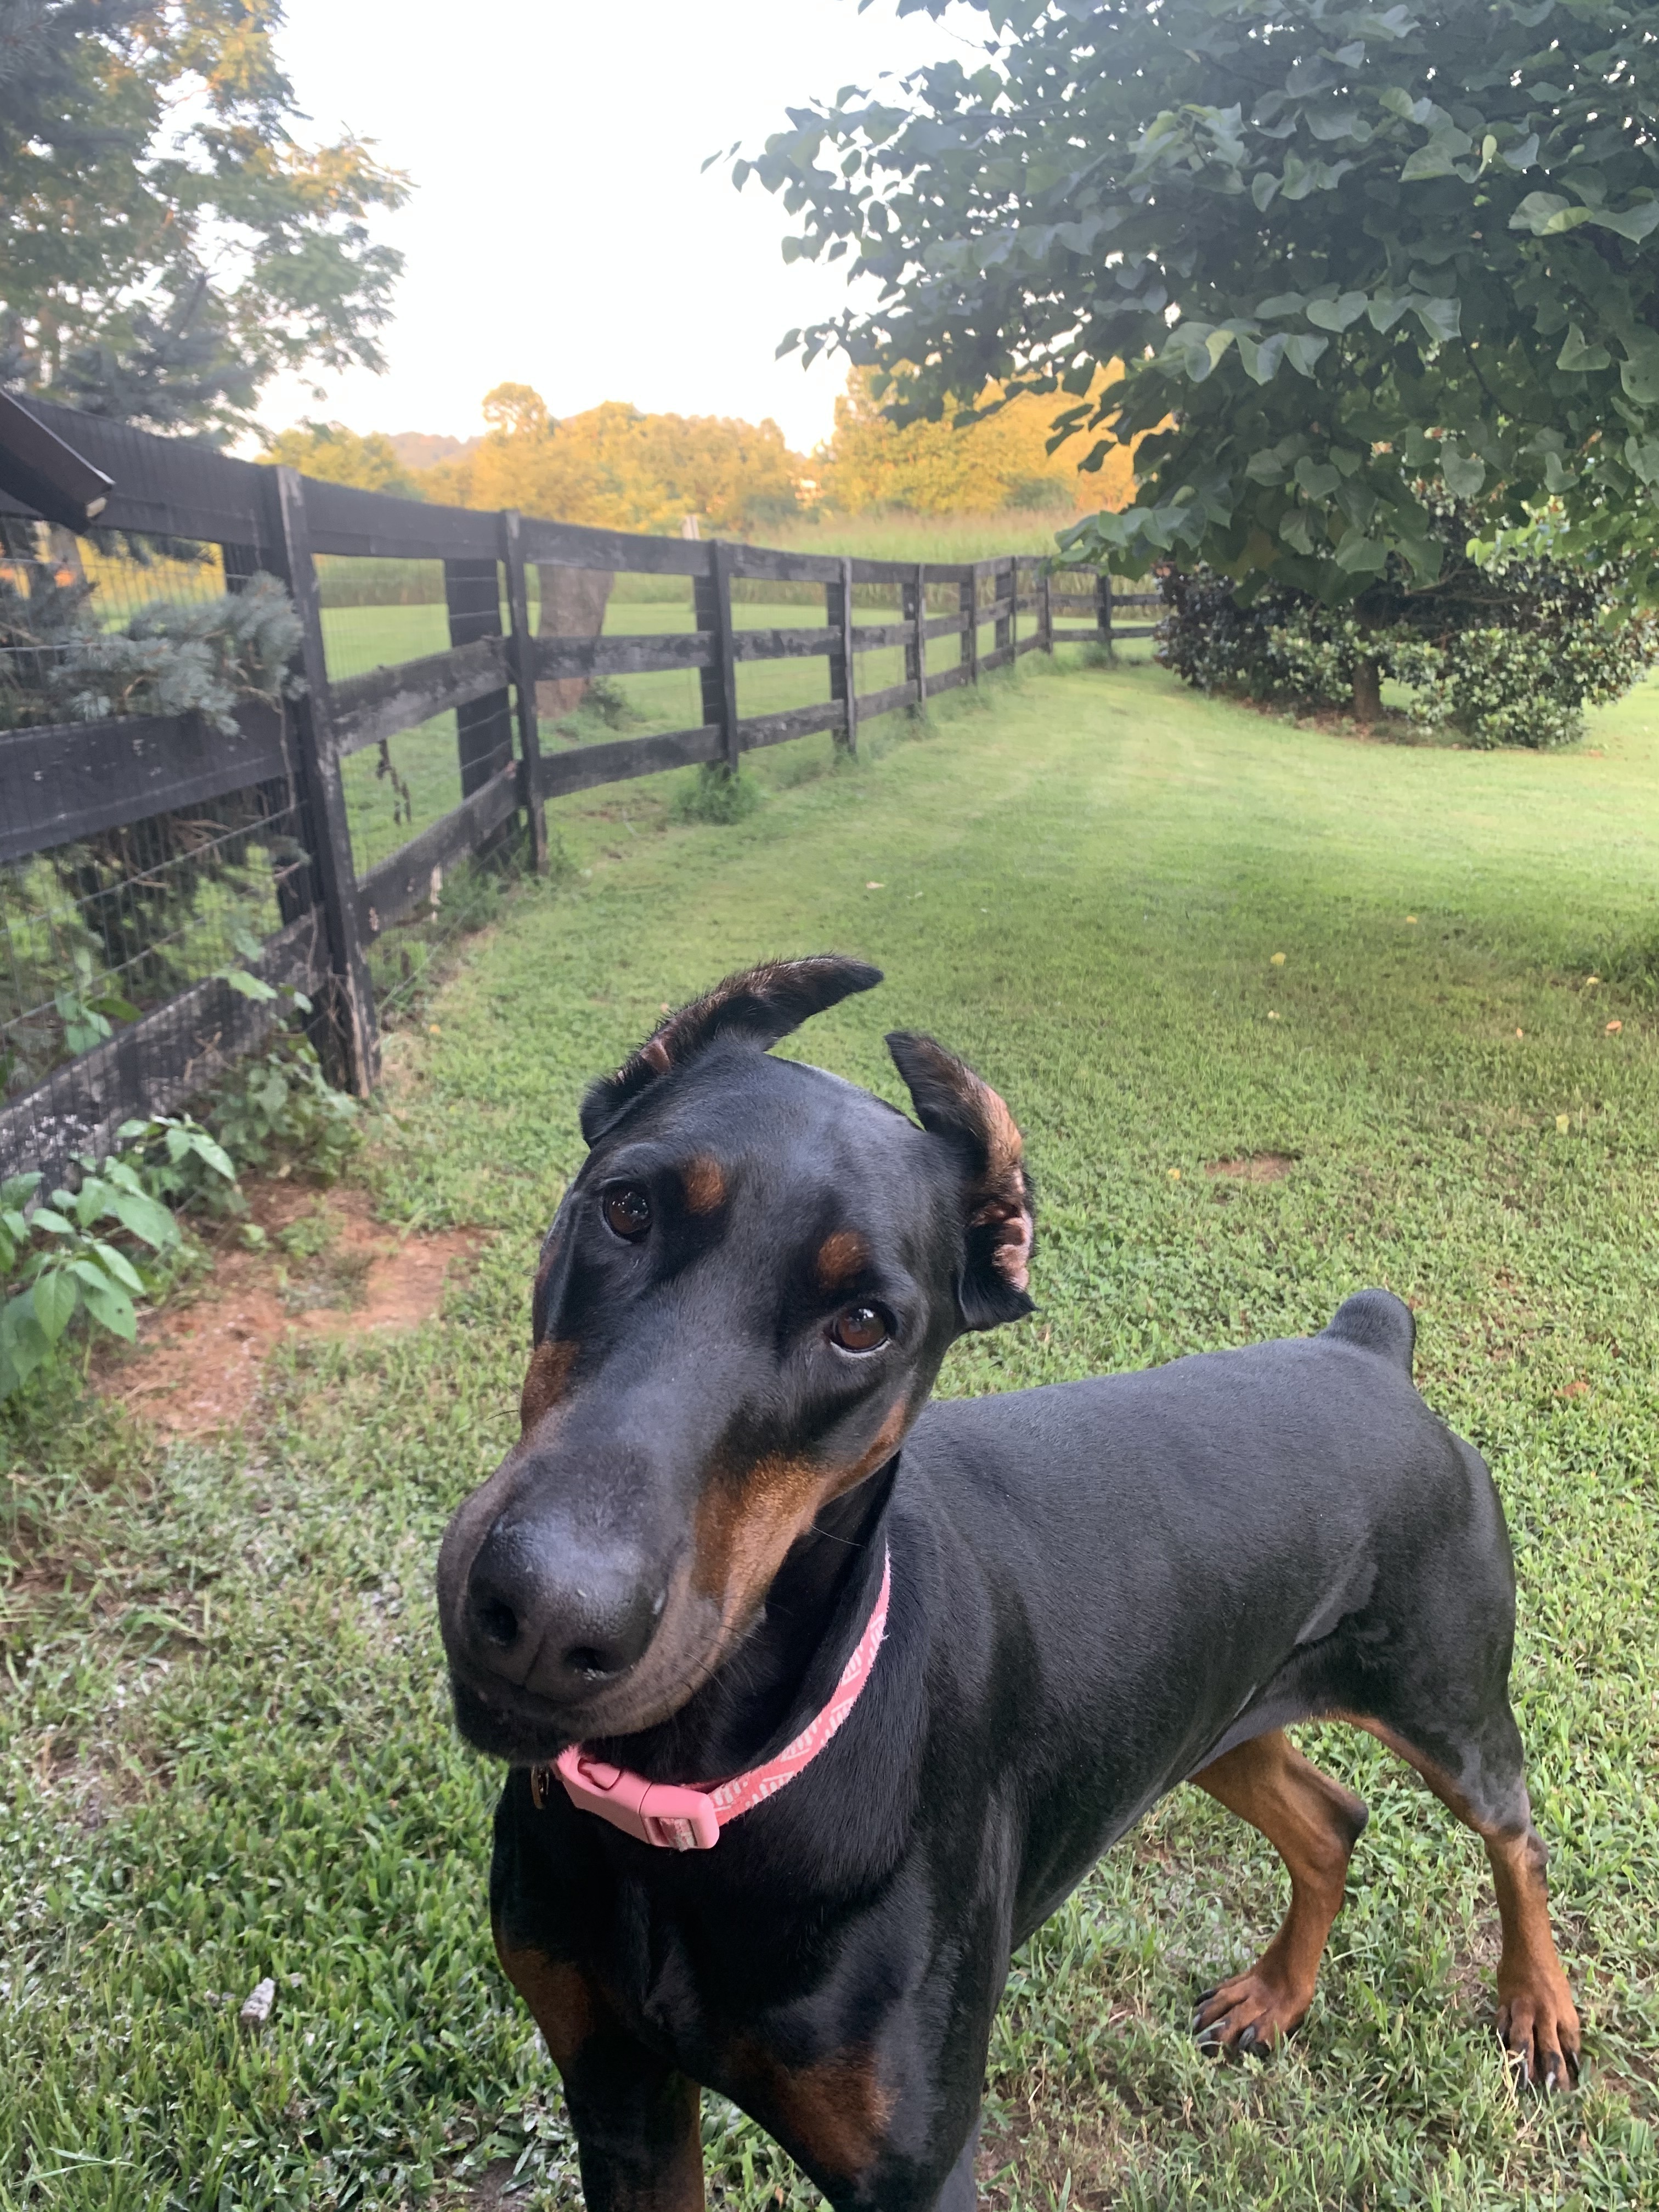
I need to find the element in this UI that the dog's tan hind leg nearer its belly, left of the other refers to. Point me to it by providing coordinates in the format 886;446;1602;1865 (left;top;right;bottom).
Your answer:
1192;1728;1365;2053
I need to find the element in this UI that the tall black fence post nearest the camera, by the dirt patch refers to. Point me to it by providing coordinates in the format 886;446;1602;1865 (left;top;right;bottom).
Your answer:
270;469;381;1097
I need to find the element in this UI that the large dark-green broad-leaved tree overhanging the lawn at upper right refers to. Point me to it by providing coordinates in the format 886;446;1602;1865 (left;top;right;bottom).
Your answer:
735;0;1659;604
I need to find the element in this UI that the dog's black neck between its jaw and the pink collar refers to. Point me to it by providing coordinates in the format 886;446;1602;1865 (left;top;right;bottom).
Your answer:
591;1453;898;1787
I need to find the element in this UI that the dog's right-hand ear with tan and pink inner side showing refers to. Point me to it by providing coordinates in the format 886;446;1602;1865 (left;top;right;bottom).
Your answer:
887;1029;1035;1329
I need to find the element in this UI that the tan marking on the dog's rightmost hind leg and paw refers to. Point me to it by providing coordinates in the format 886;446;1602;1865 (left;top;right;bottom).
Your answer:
1336;1712;1579;2090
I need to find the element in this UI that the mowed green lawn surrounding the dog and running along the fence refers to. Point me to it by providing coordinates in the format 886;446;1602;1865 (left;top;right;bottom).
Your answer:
0;664;1659;2212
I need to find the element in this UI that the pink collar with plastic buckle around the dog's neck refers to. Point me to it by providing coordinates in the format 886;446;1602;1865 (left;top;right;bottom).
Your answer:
531;1553;894;1852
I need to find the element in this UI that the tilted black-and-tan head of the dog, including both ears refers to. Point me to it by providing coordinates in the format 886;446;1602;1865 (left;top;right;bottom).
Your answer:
438;956;1033;1763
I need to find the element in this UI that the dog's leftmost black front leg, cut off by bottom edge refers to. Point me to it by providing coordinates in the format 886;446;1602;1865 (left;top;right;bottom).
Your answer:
495;1927;703;2212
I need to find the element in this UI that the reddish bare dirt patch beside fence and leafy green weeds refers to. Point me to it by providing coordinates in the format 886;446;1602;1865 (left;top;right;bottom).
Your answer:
95;1181;480;1436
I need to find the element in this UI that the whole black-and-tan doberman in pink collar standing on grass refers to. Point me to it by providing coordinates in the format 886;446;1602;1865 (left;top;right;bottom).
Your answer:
438;956;1579;2212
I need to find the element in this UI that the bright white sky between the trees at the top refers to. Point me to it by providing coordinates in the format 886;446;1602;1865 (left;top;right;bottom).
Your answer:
261;0;984;452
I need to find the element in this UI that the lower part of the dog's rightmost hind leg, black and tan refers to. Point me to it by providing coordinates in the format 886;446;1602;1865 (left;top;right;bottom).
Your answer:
1345;1699;1579;2090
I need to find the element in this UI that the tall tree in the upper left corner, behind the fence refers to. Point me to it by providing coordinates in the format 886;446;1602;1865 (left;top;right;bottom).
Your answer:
0;0;407;433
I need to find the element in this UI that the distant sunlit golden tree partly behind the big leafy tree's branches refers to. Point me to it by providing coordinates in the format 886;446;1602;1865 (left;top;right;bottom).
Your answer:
819;369;1135;515
